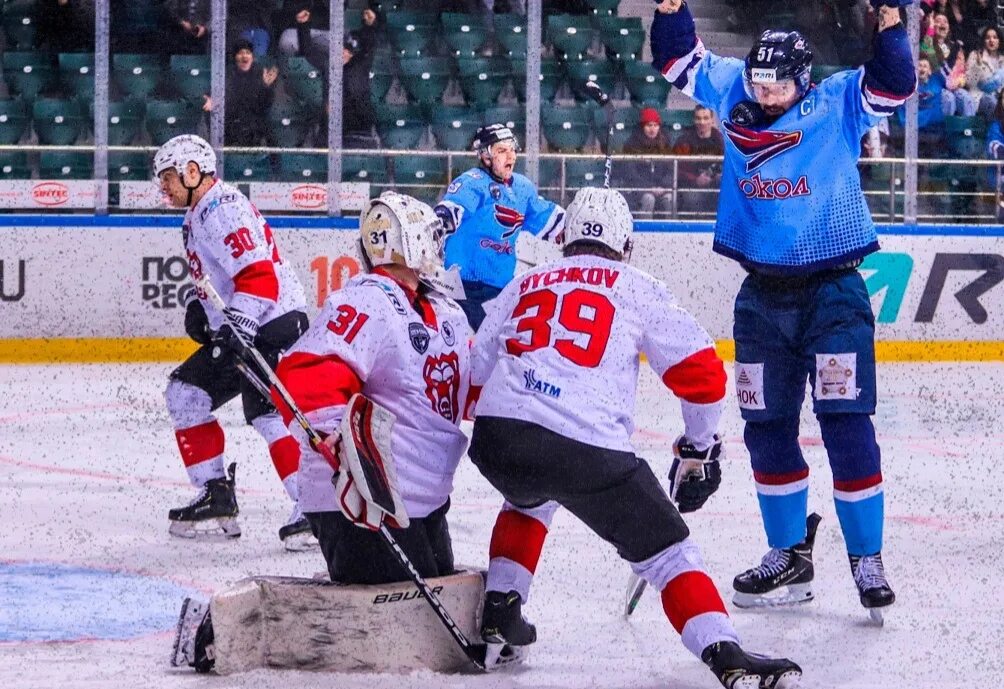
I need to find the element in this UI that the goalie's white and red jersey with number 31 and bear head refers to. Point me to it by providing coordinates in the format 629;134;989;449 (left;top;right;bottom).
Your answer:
276;268;473;517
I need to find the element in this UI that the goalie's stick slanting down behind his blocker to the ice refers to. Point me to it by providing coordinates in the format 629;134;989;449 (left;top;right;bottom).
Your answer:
197;277;506;670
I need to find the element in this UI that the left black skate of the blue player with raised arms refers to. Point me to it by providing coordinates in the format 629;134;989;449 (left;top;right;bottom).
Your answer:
732;512;822;610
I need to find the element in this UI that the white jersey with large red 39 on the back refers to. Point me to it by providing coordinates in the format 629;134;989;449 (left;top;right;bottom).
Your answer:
472;255;725;451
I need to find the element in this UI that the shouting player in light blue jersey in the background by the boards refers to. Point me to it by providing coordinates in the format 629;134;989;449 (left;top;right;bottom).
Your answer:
435;125;564;330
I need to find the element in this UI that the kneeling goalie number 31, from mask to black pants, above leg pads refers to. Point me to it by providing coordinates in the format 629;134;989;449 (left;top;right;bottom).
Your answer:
276;192;472;584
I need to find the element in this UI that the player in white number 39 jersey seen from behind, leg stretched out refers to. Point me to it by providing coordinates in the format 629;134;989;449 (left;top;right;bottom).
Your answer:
470;188;801;689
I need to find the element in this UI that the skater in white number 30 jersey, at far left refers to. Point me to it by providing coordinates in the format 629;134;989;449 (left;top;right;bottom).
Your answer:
154;135;316;550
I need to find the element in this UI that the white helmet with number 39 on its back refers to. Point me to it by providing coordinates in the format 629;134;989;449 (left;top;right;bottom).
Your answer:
561;187;635;258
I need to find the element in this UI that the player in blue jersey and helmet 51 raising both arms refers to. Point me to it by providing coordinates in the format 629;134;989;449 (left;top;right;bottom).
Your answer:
652;0;916;620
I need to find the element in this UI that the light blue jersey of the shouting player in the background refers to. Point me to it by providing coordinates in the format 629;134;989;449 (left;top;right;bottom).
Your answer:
438;168;564;287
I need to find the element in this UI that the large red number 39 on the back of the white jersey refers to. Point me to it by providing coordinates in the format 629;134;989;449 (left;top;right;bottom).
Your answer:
505;289;616;369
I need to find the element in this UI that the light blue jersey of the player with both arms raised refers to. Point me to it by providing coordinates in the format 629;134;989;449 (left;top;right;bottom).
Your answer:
653;10;913;274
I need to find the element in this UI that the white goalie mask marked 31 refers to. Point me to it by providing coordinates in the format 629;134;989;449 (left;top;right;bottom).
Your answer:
359;192;446;275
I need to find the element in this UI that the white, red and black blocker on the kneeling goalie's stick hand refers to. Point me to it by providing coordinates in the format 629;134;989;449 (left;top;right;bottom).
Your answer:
331;394;409;531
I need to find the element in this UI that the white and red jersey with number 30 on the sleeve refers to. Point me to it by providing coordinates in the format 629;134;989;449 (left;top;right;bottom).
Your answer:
182;181;306;330
